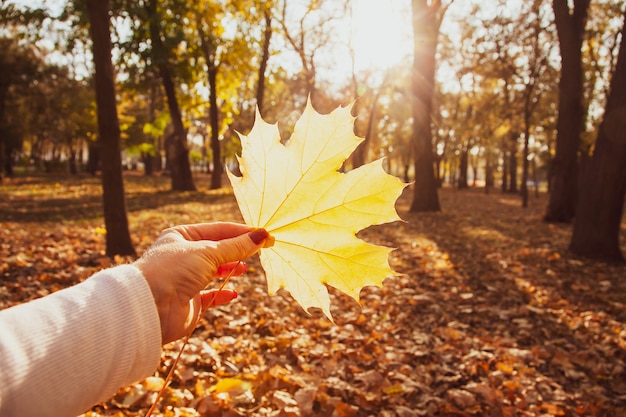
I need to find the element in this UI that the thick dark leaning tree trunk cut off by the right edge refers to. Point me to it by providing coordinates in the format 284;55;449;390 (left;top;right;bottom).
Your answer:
569;12;626;262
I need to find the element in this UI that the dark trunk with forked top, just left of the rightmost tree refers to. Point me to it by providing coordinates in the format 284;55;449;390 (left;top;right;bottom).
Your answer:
544;0;589;223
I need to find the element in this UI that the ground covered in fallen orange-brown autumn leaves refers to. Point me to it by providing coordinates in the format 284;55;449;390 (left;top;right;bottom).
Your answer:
0;171;626;417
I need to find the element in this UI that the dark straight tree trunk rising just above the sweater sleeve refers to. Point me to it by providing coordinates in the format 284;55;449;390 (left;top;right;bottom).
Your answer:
87;0;135;256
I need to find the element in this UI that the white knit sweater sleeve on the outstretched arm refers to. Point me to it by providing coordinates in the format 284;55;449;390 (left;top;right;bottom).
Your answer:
0;265;161;417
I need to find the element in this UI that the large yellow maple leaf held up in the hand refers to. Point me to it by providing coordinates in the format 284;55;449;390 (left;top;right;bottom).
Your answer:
228;102;405;320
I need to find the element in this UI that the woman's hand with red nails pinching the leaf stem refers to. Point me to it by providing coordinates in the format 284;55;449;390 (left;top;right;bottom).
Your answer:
135;223;269;344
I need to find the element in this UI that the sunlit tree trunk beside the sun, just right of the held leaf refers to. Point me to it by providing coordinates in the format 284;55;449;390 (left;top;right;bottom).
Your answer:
410;0;443;212
